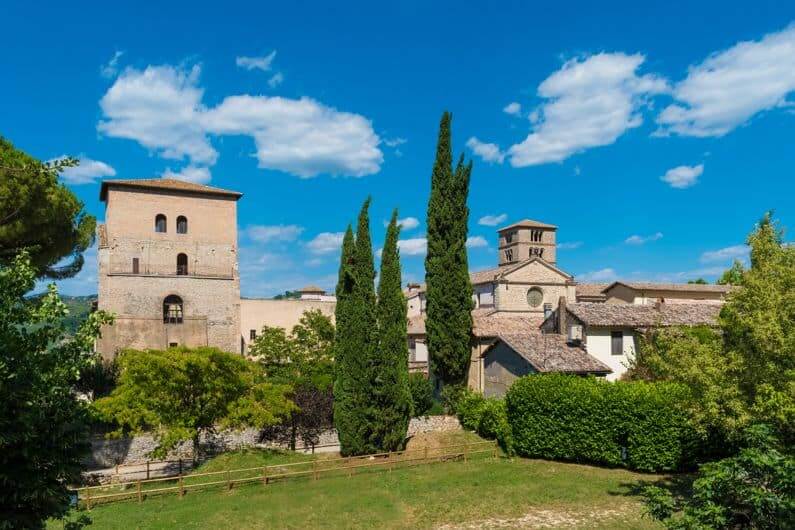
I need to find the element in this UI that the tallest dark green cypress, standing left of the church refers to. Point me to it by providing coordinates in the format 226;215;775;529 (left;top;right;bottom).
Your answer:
425;112;472;385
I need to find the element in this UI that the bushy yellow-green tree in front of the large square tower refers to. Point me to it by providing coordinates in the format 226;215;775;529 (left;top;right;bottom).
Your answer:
94;347;295;459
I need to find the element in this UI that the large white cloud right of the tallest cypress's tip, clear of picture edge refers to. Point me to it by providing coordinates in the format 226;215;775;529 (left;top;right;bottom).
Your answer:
507;53;668;167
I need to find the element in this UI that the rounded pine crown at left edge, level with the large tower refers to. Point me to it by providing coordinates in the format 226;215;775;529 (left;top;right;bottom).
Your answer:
0;137;96;278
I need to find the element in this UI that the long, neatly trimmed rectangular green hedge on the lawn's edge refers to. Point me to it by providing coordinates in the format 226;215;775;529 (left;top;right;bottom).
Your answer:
505;374;696;471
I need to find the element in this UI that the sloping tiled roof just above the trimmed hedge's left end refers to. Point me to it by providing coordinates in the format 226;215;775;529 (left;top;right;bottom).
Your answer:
484;331;612;374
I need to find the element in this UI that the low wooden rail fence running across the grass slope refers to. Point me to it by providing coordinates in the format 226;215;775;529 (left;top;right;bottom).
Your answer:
72;441;498;510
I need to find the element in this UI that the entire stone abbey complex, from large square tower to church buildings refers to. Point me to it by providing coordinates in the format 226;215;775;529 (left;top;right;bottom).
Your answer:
97;178;727;395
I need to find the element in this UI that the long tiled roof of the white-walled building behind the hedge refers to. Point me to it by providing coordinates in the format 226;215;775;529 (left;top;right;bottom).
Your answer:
564;302;721;328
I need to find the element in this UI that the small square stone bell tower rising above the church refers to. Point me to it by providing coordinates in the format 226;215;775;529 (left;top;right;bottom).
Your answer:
497;219;558;267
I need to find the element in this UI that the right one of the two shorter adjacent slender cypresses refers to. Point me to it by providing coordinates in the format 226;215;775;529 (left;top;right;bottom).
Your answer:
371;210;412;451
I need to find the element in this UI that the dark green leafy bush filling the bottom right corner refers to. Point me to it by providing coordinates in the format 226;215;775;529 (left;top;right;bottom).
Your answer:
644;425;795;530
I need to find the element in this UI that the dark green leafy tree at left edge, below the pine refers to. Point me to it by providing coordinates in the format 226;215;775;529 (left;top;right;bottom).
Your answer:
0;254;112;528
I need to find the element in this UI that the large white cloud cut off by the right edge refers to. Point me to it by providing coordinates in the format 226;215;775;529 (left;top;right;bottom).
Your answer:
657;24;795;137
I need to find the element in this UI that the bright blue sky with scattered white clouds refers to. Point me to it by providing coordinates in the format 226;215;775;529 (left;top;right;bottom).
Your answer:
0;1;795;296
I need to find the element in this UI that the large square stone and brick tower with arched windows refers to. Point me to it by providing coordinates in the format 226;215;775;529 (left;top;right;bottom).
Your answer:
97;178;242;357
